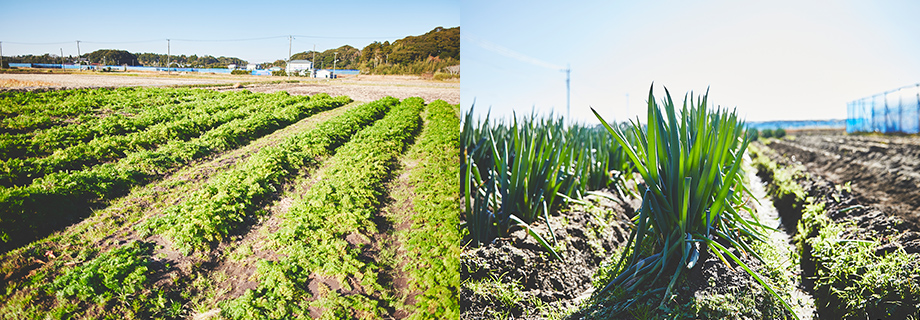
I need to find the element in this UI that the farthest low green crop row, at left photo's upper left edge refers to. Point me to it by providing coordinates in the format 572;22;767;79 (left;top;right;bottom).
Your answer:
0;88;212;134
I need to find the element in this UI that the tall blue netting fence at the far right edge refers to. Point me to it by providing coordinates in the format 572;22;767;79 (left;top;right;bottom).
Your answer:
847;84;920;133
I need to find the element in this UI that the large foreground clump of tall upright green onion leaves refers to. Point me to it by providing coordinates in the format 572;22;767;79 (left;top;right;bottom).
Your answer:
592;87;795;315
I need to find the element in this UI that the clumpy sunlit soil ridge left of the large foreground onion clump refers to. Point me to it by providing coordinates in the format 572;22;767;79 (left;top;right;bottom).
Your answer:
460;193;640;319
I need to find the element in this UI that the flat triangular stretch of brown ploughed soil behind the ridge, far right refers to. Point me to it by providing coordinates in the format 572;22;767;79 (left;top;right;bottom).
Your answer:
768;136;920;229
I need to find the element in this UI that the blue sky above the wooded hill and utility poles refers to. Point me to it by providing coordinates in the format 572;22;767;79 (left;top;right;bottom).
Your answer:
0;0;460;63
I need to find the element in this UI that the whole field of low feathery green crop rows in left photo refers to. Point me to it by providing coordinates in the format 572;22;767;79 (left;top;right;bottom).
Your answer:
0;88;459;319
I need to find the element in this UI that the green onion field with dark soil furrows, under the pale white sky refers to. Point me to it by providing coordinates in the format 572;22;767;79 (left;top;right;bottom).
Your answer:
459;88;920;319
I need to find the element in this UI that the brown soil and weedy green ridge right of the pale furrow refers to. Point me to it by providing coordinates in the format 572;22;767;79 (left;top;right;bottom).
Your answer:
755;134;920;319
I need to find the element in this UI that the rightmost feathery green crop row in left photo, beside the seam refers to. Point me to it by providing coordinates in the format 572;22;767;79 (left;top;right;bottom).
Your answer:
397;100;460;319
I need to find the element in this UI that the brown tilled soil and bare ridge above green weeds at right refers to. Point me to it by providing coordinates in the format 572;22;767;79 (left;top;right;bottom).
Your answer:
768;136;920;255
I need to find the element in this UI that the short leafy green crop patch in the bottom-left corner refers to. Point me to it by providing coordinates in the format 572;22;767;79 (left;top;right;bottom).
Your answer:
0;241;182;319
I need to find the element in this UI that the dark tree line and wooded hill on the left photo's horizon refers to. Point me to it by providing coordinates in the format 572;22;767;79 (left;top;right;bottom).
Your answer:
3;27;460;74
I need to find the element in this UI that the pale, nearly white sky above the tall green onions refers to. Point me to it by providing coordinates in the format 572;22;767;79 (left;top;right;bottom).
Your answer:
461;0;920;123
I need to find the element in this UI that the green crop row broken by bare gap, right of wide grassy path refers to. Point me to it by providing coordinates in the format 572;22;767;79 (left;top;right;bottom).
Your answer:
0;95;388;318
